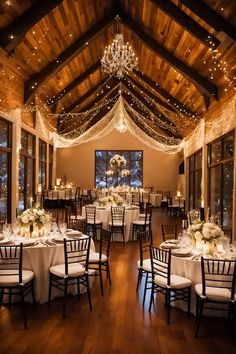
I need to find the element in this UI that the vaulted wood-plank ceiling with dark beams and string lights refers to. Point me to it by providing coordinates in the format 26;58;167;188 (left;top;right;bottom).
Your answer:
0;0;236;136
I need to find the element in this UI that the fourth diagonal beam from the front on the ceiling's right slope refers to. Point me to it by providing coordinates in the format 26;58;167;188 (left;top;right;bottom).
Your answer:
122;80;182;139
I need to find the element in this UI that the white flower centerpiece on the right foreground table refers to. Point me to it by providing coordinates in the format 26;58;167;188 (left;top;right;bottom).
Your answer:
187;219;224;242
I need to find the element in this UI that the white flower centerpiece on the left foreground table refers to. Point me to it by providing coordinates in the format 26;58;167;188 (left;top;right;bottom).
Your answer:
17;208;51;226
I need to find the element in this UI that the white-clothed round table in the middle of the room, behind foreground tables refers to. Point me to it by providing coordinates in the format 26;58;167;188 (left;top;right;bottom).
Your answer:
82;205;139;242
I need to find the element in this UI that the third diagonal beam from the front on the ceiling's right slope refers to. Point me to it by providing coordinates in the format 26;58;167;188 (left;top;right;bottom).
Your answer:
133;70;195;117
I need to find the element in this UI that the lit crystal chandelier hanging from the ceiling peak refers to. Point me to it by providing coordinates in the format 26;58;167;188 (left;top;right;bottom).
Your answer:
101;16;138;79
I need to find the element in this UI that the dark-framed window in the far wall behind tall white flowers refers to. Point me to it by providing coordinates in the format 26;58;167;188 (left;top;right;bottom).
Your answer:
95;150;143;188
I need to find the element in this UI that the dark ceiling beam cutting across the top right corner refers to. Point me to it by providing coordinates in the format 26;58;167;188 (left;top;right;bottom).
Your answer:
180;0;236;40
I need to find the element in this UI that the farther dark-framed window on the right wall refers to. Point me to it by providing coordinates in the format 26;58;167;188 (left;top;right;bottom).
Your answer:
189;150;202;210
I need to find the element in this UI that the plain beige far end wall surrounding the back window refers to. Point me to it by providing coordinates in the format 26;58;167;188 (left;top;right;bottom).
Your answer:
56;131;179;192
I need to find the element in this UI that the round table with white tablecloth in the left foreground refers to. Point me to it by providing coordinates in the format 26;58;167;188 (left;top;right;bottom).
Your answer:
2;235;95;304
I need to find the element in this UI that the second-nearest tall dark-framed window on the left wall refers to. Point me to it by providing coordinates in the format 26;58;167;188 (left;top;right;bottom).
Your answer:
18;129;35;210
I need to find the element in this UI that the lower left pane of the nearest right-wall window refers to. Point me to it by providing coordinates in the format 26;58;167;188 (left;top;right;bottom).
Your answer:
210;165;221;215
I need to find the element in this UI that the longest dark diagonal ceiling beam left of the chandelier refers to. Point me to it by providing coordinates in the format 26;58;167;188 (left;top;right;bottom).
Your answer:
24;12;116;103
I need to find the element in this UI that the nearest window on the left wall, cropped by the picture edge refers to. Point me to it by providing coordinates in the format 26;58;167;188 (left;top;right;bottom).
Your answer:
0;118;12;222
